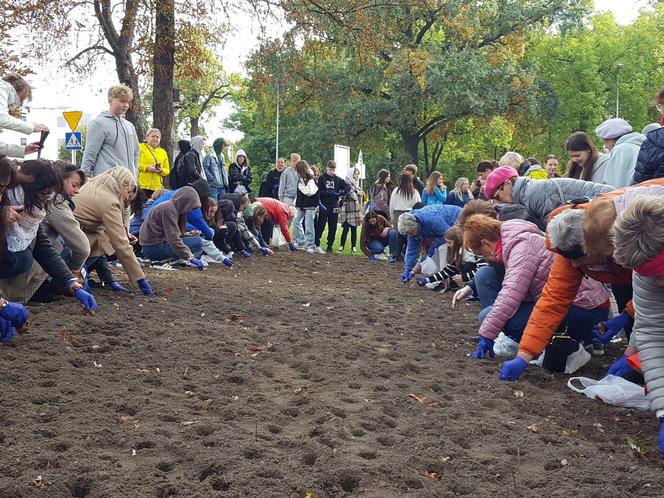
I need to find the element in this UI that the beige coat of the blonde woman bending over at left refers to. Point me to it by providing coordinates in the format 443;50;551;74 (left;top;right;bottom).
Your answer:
74;183;145;282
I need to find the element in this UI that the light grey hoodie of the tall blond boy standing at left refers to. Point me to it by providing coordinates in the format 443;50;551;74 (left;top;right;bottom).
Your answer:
81;111;140;177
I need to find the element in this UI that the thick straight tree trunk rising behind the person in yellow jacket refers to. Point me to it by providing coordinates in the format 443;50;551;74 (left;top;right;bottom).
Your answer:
152;0;175;161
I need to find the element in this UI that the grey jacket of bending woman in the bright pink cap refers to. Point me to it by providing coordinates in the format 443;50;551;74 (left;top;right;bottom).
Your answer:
512;176;614;230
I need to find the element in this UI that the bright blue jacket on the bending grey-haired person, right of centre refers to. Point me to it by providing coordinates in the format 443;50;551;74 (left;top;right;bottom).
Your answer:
404;204;461;272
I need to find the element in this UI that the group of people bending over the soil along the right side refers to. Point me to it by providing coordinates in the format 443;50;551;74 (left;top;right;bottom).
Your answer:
376;163;664;454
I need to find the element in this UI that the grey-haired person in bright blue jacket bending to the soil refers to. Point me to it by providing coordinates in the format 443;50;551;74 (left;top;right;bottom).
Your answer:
398;204;462;282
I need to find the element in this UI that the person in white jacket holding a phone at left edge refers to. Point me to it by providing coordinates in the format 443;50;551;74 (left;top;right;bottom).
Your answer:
0;73;48;158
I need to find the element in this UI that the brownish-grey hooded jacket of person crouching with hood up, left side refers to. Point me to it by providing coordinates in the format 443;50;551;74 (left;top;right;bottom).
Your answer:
138;187;201;260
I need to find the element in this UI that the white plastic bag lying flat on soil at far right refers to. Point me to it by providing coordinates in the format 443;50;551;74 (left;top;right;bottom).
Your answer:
567;375;650;411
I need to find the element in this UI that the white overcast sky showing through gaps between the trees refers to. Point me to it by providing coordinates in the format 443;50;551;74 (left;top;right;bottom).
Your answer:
3;0;648;157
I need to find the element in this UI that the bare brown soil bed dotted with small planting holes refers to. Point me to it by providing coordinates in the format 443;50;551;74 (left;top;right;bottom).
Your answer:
0;251;664;498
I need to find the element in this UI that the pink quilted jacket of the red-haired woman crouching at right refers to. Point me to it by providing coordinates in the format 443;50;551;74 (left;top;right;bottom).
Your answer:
480;220;609;339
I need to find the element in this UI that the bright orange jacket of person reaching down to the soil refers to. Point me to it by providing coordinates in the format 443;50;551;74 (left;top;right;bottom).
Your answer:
519;179;664;356
